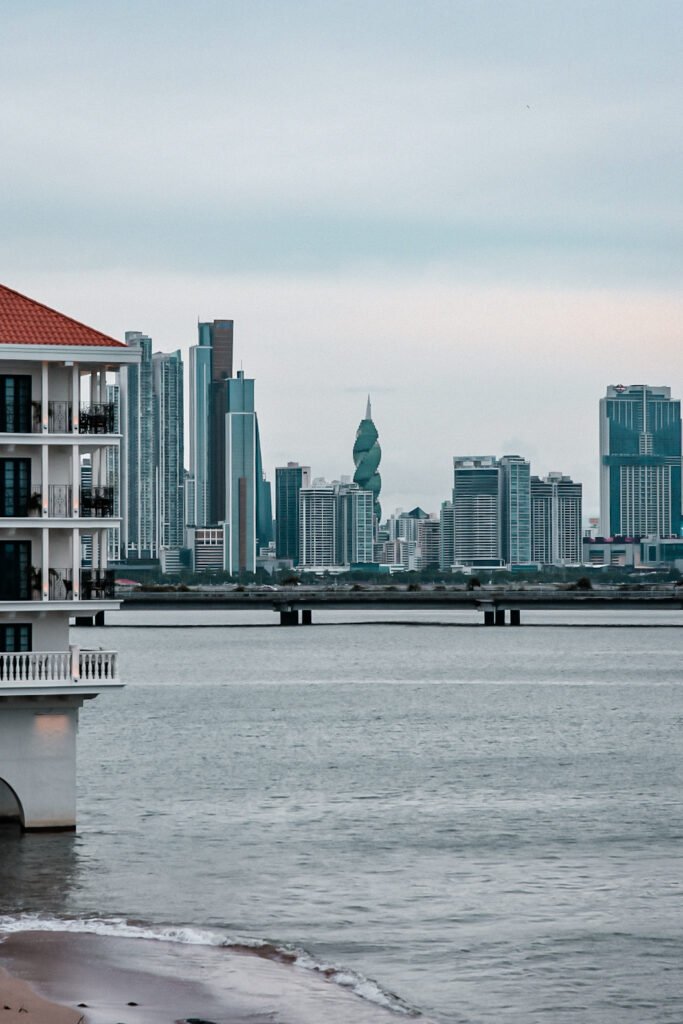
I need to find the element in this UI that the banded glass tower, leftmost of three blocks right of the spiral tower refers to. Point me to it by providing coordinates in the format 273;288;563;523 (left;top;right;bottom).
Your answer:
453;456;503;565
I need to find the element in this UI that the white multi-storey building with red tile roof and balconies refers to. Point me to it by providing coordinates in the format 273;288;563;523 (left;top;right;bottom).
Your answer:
0;286;138;829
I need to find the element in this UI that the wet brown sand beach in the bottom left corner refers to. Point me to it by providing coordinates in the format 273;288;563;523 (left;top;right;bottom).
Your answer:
0;931;409;1024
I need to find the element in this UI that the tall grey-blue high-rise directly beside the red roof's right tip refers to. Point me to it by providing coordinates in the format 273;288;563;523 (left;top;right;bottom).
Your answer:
122;331;158;559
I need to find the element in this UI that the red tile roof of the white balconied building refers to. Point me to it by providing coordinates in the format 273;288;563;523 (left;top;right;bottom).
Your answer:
0;285;126;348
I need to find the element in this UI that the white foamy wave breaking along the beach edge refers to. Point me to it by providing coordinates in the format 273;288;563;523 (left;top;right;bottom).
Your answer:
0;913;422;1017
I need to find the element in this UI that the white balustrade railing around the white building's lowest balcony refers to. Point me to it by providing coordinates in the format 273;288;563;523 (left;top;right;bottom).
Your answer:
0;648;119;686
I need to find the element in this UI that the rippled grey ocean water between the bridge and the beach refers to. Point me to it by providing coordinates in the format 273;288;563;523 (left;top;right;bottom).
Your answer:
0;613;683;1024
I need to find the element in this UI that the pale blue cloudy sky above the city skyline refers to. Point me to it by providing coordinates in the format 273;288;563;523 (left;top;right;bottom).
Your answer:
0;0;683;515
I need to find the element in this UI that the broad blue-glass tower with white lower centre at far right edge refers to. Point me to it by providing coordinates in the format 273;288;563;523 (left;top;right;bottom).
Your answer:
600;384;681;537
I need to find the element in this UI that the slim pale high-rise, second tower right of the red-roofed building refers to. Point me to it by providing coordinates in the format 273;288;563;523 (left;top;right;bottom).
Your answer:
152;350;185;550
